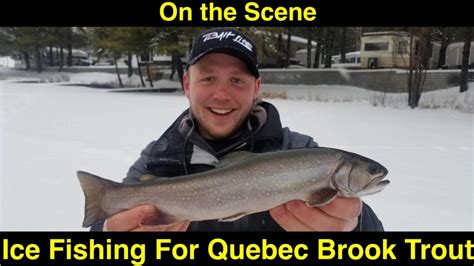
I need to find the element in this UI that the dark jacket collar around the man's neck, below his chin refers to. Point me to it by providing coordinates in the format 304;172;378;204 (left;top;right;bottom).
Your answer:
151;101;283;170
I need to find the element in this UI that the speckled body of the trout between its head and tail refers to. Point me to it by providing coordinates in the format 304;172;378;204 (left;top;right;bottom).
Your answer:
82;149;392;227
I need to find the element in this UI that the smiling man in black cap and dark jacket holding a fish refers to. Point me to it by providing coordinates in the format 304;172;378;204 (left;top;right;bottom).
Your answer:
92;29;383;231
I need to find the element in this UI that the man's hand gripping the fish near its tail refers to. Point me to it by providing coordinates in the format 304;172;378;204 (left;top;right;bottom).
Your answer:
104;205;189;232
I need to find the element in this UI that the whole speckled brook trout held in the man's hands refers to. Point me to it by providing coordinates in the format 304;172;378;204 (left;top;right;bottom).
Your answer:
77;147;390;227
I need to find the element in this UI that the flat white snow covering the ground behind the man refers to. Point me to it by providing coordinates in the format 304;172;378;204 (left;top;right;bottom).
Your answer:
0;67;474;231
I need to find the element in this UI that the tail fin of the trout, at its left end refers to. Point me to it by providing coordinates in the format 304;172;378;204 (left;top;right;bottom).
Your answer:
77;171;120;227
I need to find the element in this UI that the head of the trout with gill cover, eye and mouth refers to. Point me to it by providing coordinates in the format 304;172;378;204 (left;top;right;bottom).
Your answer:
333;153;390;197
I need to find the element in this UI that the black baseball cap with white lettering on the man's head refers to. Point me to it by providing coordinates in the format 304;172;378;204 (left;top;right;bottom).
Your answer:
187;28;260;78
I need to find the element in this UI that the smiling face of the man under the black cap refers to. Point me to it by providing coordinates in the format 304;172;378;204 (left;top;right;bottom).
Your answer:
183;53;260;139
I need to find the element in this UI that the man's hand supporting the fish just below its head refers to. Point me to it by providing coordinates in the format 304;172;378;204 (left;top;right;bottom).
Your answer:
270;198;362;231
